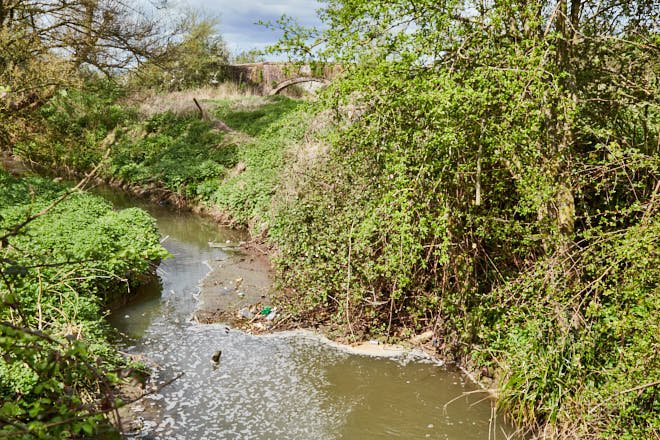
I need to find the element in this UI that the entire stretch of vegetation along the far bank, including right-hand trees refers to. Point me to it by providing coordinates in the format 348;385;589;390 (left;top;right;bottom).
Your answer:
0;0;660;439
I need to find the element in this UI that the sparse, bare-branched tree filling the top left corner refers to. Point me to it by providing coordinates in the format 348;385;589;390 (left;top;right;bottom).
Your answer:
0;0;172;144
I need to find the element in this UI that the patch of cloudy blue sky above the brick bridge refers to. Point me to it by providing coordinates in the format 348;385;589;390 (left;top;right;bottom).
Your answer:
187;0;321;59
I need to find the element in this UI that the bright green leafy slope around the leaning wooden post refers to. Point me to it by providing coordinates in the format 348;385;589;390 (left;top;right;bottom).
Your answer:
109;96;309;231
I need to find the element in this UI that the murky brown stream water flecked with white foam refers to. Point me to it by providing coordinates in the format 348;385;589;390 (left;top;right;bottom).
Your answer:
1;160;514;440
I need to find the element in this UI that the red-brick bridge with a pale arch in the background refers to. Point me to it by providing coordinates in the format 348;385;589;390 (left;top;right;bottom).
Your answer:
225;62;342;95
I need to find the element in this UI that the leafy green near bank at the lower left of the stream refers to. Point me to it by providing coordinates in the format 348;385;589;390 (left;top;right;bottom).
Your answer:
0;169;167;438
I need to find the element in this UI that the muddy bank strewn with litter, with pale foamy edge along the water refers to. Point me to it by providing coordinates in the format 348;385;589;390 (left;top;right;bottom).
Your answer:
194;249;497;397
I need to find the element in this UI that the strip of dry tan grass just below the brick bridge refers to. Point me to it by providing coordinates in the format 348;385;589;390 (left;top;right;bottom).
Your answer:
126;83;256;117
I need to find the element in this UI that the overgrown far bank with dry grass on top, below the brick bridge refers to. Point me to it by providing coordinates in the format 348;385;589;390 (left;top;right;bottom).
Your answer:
13;83;314;231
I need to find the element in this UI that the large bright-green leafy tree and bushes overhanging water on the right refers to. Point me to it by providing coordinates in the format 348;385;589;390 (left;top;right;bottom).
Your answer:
272;0;660;438
